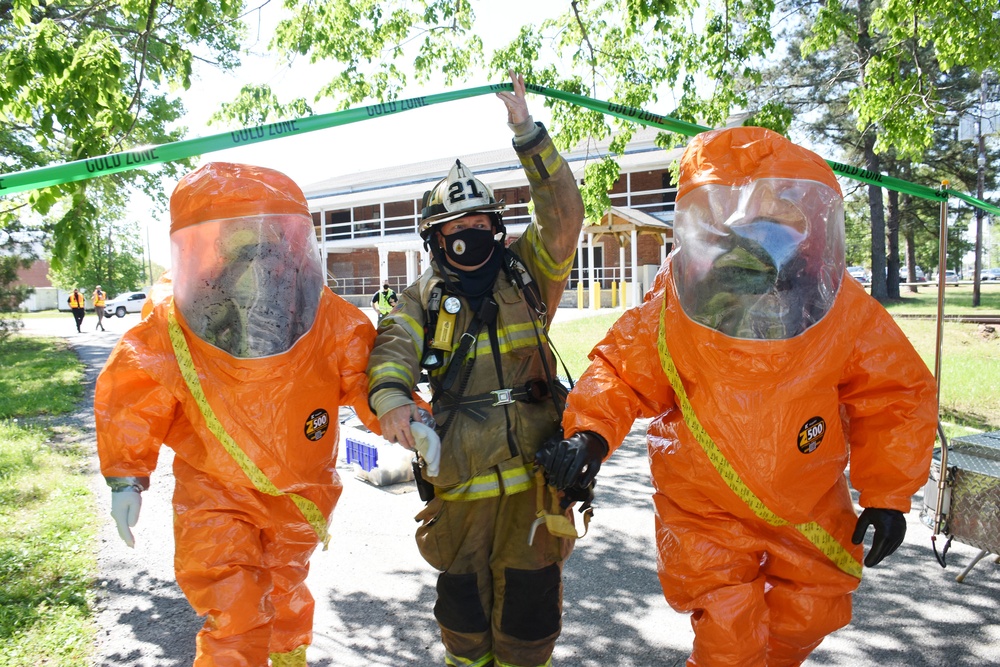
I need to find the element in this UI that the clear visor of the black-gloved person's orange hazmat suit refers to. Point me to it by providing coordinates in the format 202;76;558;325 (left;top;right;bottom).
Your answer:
673;178;845;340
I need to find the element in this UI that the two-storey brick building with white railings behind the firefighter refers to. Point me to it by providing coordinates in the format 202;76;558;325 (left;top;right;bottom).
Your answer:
303;129;683;307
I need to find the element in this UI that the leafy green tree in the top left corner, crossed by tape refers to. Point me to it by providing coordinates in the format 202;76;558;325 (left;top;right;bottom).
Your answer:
0;0;250;267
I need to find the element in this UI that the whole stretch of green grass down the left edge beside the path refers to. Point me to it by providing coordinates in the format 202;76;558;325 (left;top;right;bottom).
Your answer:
0;338;97;667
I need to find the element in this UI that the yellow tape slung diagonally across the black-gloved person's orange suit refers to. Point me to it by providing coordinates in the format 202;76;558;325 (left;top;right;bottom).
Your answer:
656;299;861;579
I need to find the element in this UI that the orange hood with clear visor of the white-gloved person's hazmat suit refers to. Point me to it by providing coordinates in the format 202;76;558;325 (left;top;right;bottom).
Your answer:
170;162;324;358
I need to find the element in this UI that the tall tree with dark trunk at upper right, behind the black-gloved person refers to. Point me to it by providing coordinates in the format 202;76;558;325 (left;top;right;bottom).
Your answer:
761;0;1000;299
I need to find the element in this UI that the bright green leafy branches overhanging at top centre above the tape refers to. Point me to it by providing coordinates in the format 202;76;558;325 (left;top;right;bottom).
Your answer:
232;0;774;220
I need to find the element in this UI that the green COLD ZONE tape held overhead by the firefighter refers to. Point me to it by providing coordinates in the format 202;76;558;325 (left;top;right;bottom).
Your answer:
0;83;1000;215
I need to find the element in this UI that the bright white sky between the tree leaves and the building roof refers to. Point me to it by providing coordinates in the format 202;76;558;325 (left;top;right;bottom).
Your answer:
139;0;564;267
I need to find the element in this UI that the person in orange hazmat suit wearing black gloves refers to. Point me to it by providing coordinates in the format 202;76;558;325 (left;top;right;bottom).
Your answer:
539;127;937;666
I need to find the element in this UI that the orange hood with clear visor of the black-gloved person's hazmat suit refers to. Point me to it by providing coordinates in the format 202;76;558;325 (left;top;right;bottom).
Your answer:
672;127;845;340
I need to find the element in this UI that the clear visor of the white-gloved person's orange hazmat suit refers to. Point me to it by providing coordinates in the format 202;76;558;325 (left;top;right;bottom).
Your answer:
170;214;323;358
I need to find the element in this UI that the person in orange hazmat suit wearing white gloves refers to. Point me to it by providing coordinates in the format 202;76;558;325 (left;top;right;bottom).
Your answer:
94;163;378;667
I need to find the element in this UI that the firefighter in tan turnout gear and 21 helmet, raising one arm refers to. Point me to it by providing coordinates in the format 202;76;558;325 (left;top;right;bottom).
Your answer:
368;73;583;667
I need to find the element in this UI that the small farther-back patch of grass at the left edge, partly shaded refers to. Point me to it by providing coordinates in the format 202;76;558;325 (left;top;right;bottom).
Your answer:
0;336;83;418
